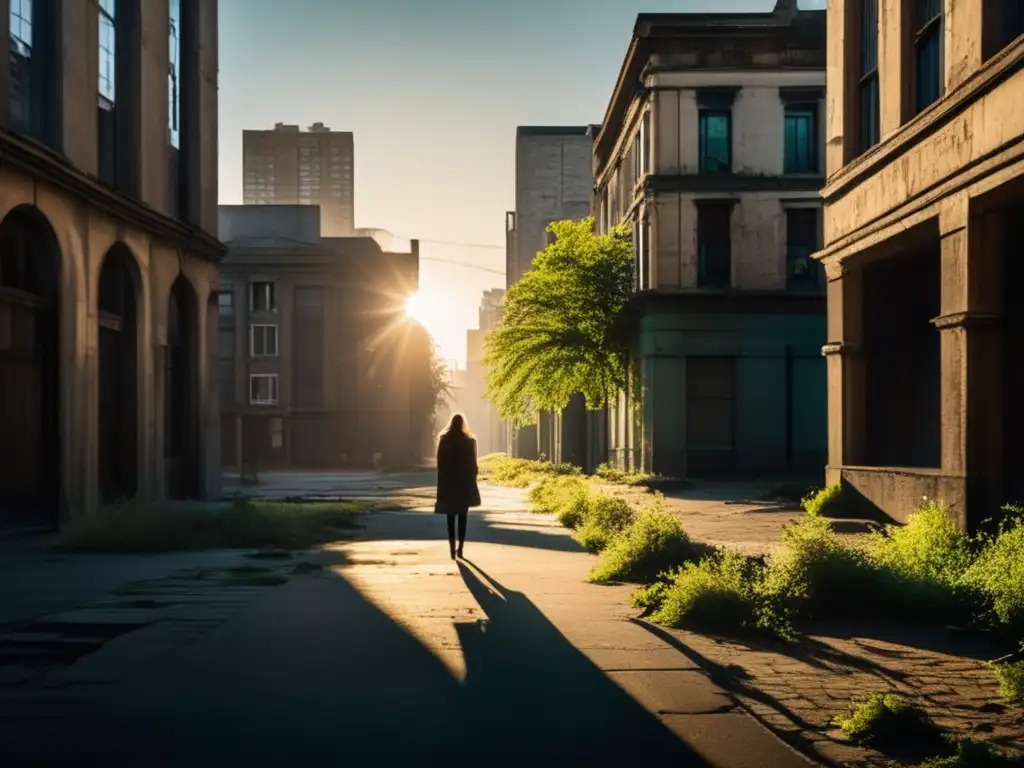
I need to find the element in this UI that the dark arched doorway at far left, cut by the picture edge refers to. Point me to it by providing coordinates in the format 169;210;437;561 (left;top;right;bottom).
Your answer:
0;206;61;525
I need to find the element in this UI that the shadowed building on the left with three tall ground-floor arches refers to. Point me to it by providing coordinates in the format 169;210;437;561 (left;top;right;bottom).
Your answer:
0;0;223;526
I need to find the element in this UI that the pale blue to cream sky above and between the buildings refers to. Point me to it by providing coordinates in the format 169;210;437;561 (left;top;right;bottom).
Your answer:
220;0;824;362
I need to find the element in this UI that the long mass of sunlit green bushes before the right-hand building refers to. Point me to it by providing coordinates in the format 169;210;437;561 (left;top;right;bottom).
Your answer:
622;501;1024;637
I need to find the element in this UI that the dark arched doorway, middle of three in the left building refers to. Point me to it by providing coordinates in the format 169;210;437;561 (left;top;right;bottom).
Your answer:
98;243;138;504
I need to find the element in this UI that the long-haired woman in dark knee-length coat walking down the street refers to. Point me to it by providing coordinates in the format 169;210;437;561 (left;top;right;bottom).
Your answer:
434;414;480;560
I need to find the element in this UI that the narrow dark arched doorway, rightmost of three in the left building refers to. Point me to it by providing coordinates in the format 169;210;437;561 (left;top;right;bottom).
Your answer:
164;276;200;499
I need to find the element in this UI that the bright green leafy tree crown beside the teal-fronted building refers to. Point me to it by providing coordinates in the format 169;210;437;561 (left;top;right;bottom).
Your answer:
484;218;634;426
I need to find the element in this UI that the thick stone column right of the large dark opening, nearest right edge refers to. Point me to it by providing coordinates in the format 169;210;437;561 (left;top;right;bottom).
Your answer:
932;196;1004;525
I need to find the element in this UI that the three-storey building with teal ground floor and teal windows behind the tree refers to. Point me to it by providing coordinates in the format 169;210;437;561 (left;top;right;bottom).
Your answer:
590;2;827;477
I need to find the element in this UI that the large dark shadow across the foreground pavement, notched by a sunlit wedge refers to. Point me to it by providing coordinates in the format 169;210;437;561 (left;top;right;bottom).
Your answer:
0;551;706;767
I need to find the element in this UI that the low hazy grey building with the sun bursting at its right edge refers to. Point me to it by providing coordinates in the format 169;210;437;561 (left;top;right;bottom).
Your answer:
218;205;423;472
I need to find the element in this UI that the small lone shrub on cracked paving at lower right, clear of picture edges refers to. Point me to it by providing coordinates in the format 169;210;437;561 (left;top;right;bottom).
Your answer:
833;693;946;754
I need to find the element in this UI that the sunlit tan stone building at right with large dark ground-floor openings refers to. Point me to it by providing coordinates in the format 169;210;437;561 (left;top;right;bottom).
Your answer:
818;0;1024;527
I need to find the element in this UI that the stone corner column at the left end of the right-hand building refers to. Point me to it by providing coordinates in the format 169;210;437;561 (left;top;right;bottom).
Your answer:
821;263;866;484
